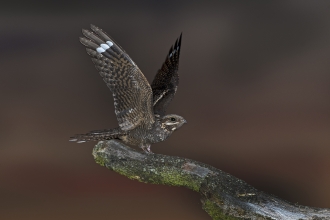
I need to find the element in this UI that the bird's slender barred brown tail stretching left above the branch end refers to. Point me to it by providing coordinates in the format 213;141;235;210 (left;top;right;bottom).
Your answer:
70;128;126;143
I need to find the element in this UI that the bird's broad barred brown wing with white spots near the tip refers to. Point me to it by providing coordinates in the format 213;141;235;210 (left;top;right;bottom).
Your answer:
80;25;155;131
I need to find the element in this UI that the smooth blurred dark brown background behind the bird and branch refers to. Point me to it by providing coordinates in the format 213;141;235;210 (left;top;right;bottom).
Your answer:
0;0;330;220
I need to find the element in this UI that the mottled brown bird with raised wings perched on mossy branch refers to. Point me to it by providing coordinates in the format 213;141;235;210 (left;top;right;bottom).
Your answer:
70;25;187;153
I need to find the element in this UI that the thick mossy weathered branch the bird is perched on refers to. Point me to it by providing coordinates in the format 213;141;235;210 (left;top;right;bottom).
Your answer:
93;140;330;220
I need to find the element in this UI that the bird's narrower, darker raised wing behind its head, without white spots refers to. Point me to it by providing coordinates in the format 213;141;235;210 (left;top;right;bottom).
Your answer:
151;34;182;116
